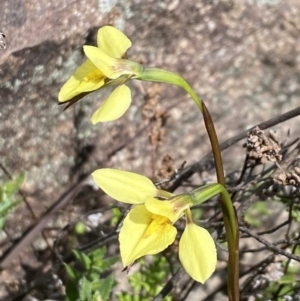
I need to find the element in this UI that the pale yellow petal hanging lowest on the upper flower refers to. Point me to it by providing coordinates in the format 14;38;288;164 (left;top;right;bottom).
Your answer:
91;85;131;124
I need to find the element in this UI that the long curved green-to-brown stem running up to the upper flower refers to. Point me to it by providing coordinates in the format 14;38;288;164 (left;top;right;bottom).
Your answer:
138;68;239;301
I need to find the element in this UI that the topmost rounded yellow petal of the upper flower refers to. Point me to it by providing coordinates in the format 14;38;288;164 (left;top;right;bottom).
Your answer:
97;26;131;58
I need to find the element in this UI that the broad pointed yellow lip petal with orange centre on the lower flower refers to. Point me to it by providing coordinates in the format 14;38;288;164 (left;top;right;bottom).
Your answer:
119;205;177;267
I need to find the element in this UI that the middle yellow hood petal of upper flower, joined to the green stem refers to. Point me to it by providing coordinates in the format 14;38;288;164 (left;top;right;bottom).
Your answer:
83;46;138;79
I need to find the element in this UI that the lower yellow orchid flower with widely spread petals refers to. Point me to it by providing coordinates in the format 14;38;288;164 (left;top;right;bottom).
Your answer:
92;168;217;283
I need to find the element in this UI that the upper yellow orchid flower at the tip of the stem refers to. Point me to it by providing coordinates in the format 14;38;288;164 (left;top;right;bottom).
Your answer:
58;26;142;124
